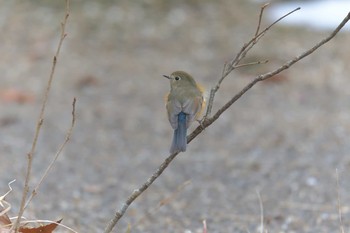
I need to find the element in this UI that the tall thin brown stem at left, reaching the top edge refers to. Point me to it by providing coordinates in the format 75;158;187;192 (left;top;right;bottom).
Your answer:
13;0;69;233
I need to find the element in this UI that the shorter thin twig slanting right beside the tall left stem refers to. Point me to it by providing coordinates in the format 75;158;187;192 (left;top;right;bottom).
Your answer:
24;98;76;209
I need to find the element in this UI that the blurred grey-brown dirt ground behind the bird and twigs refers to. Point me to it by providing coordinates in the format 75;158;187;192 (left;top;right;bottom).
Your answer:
0;0;350;233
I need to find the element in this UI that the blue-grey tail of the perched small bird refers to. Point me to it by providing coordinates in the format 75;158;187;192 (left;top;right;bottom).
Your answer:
170;112;187;154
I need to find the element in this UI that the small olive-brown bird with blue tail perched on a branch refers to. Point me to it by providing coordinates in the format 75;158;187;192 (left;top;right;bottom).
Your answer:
163;71;205;154
